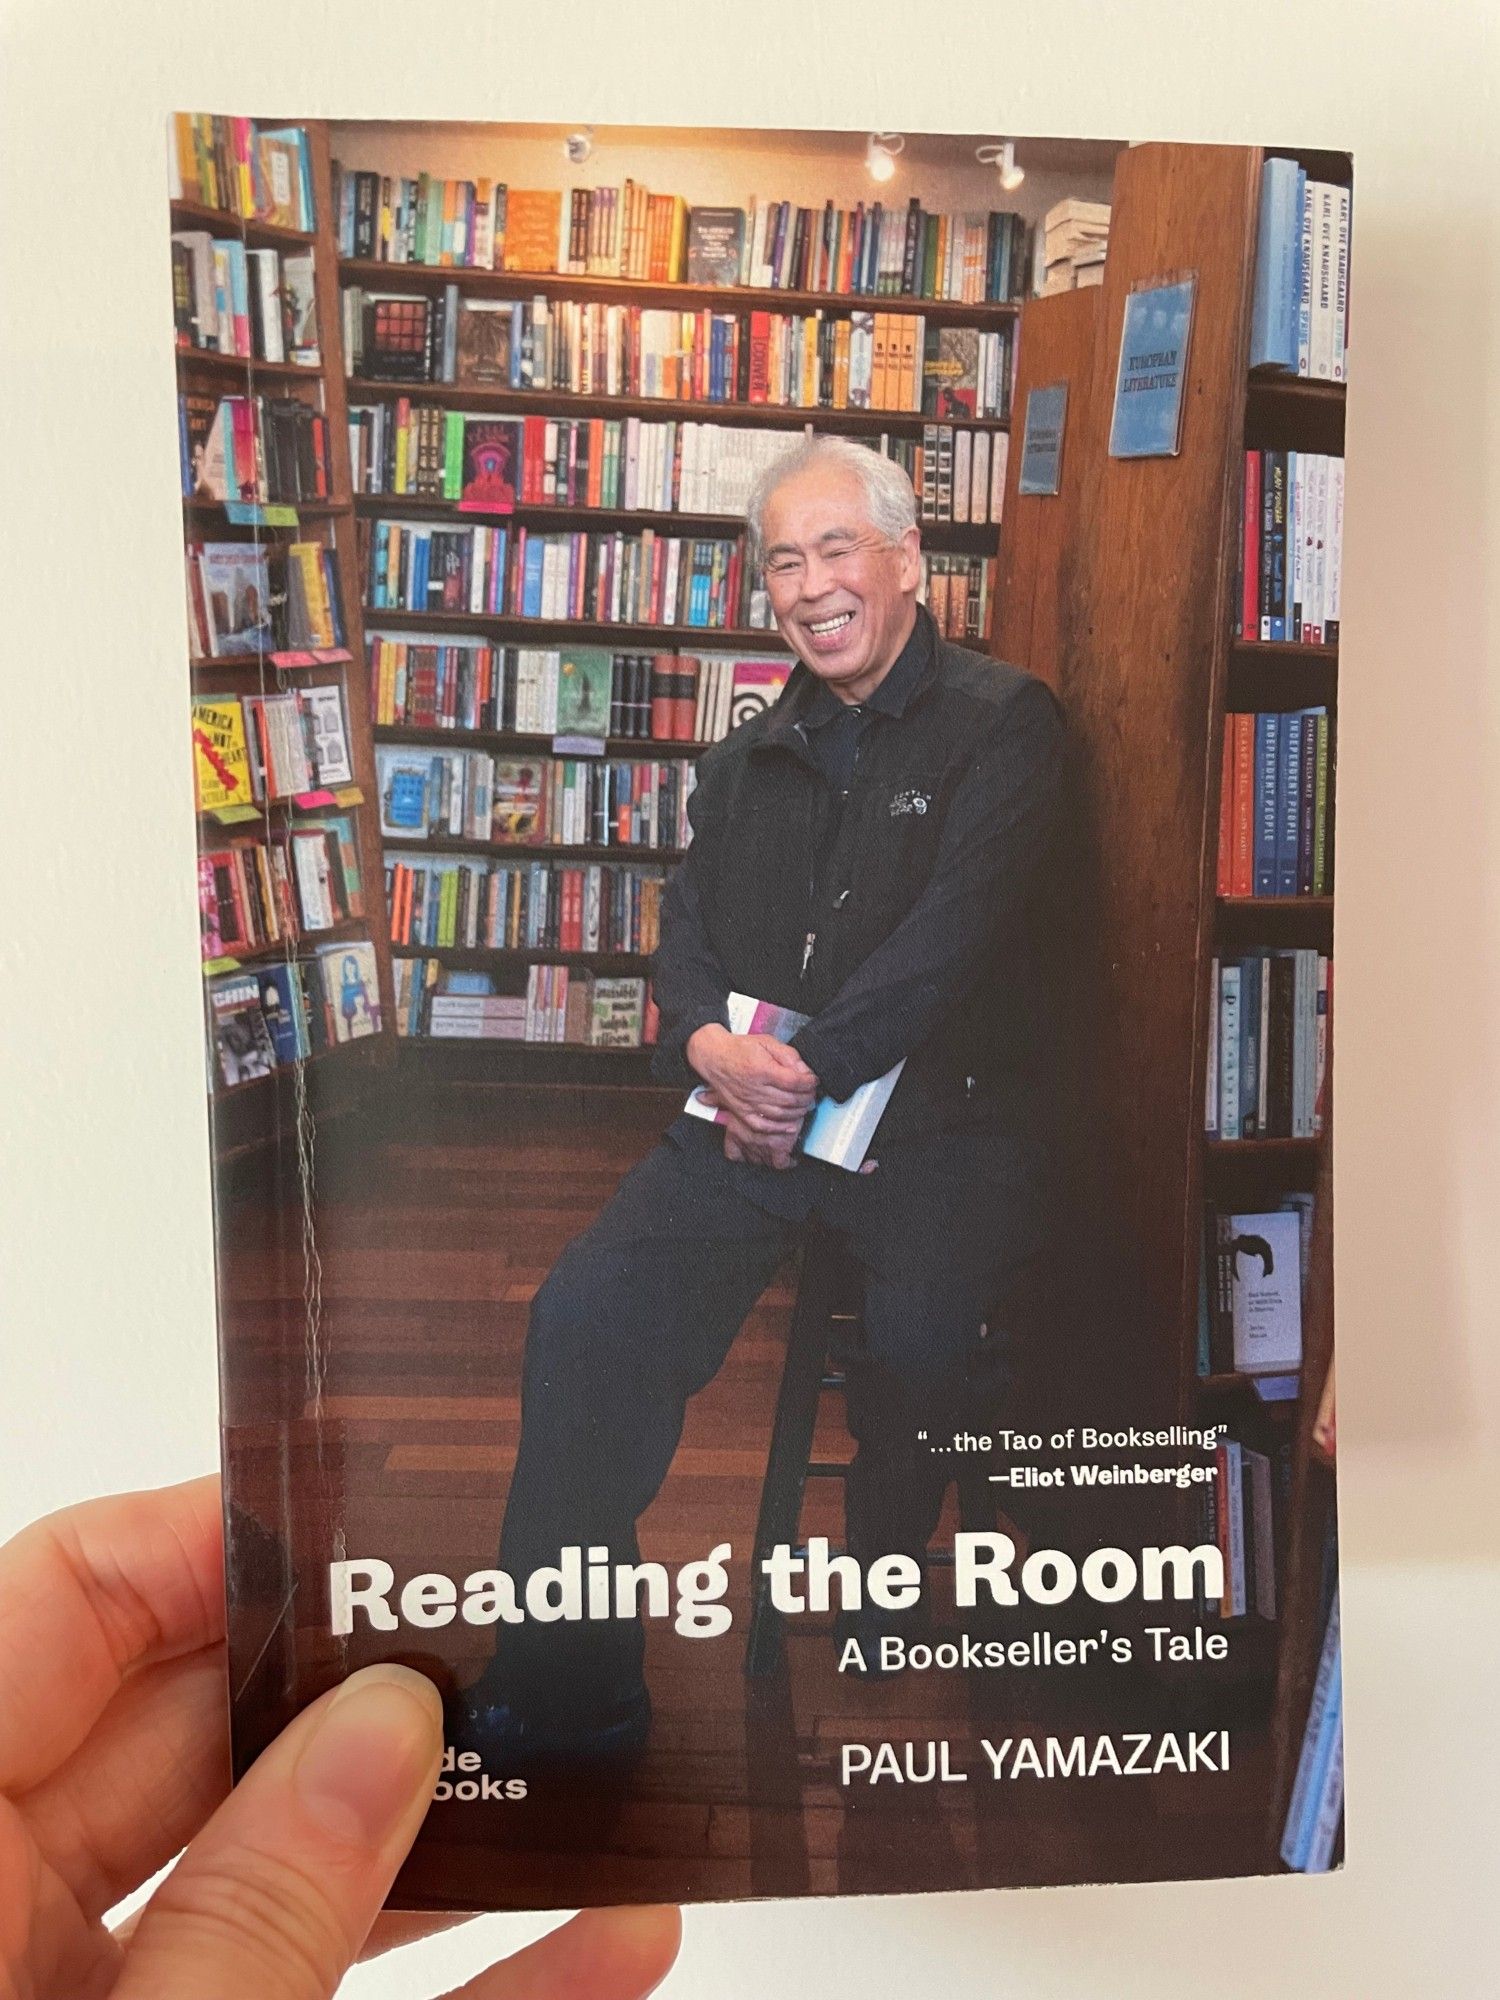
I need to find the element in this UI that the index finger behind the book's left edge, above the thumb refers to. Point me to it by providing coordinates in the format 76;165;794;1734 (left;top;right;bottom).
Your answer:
0;1476;224;1792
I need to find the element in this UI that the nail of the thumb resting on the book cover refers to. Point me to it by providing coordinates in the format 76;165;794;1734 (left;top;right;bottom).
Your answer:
292;1666;442;1848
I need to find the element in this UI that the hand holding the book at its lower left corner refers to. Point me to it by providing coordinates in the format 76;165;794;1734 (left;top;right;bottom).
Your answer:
0;1478;678;2000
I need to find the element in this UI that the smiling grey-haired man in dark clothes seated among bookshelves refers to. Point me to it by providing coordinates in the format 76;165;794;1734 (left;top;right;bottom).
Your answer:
456;440;1062;1758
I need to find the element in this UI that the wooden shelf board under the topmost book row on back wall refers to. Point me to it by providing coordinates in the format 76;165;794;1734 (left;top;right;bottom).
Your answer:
338;258;1020;326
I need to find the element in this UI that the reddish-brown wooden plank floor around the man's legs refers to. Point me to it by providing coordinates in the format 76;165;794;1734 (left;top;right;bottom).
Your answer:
220;1086;1266;1908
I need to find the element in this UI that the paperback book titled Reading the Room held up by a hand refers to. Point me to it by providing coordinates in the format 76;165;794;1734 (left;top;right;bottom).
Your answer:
170;114;1356;1910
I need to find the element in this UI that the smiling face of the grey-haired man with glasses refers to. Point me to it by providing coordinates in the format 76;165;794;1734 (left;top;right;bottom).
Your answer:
764;466;922;702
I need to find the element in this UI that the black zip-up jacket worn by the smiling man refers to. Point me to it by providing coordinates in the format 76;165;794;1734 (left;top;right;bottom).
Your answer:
652;606;1064;1150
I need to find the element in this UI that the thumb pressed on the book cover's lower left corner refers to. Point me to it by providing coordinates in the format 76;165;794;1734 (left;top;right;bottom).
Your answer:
116;1666;442;2000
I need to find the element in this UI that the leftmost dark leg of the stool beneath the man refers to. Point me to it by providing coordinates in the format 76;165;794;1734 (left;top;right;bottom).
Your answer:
744;1230;832;1676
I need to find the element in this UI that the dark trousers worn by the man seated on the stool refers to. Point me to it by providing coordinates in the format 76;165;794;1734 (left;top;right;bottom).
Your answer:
492;1132;1050;1708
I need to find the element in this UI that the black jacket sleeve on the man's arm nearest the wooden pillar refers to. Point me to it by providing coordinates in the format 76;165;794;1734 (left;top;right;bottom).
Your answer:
792;680;1064;1100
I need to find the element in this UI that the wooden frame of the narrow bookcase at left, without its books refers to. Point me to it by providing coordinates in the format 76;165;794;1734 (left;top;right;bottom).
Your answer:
170;120;396;1162
